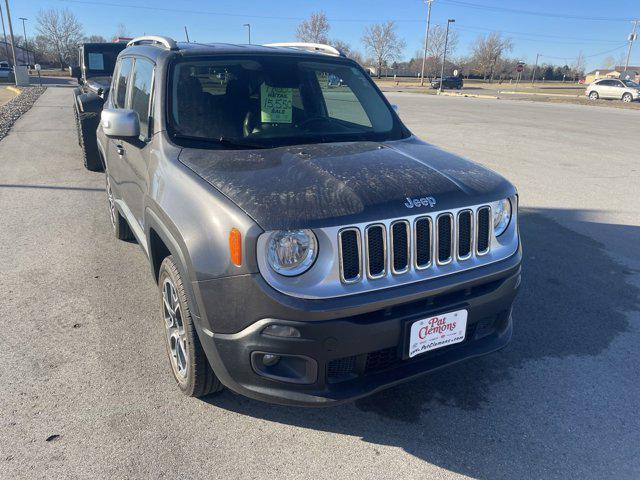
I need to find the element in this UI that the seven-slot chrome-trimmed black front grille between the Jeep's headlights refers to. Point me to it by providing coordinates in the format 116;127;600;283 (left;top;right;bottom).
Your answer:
338;206;491;283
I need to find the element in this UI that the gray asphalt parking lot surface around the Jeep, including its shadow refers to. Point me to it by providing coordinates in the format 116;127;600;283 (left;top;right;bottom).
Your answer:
0;87;640;479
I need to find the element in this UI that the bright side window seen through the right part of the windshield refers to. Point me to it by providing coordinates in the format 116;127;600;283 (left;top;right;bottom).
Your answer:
316;70;371;127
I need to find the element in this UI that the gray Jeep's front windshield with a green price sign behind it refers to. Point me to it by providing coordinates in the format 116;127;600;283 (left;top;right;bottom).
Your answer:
169;55;408;147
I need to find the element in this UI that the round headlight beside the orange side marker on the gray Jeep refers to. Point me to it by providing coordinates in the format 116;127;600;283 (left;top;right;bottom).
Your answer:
267;230;318;277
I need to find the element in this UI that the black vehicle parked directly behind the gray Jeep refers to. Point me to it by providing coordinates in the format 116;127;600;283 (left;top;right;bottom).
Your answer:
71;43;127;172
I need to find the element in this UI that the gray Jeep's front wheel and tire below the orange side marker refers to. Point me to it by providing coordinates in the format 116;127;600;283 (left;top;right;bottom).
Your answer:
158;256;224;398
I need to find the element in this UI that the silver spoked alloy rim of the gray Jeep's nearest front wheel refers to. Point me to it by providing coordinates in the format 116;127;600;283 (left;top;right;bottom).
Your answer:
162;278;189;379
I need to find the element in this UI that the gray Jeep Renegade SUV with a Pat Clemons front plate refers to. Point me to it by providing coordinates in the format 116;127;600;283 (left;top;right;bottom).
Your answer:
97;37;522;405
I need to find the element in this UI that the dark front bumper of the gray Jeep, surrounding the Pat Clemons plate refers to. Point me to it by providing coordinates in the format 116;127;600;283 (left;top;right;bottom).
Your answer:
196;246;522;406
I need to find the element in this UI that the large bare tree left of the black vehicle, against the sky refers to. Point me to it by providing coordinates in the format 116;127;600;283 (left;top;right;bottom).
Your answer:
36;8;83;70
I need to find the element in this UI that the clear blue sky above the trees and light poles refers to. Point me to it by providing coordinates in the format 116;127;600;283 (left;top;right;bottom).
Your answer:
8;0;640;70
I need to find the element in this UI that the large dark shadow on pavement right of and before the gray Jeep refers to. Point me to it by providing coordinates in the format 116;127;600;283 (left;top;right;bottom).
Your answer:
207;209;640;479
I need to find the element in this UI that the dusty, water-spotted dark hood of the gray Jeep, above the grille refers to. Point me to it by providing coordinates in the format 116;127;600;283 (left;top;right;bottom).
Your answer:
179;137;515;230
